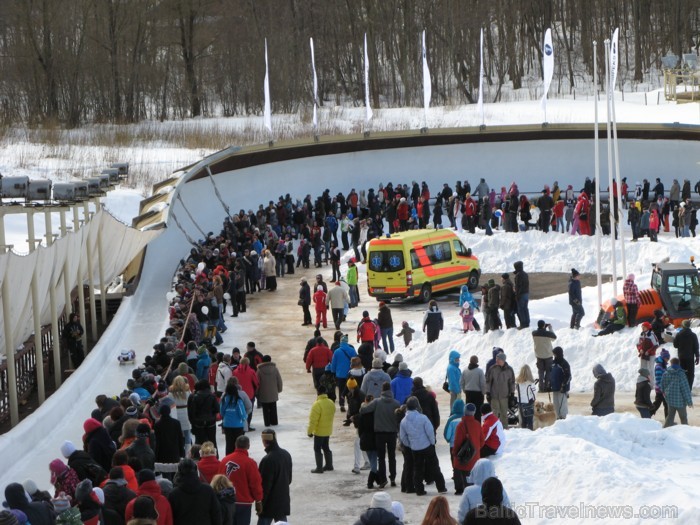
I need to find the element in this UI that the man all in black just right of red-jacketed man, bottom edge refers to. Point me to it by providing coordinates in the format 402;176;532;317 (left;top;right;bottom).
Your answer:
258;428;292;525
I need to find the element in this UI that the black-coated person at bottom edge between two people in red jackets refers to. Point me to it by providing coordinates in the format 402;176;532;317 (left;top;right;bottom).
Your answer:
168;459;221;525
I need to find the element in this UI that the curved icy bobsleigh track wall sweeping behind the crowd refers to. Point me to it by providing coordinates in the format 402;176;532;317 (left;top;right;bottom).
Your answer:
0;126;700;485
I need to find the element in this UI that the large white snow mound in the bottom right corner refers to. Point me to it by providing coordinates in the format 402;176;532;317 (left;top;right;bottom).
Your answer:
496;414;700;524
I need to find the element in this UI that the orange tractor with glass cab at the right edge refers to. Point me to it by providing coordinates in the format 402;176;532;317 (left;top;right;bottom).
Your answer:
595;257;700;328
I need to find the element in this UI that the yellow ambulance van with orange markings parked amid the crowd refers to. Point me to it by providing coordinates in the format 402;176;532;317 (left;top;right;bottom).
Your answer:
367;229;481;302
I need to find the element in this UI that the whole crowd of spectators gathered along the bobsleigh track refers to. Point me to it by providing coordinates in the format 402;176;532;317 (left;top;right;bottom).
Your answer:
5;175;700;525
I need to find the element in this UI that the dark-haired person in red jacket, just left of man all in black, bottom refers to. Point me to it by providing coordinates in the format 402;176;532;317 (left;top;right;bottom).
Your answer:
219;436;263;525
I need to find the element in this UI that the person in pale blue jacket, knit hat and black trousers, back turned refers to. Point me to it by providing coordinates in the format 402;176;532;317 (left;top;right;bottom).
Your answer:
399;396;447;496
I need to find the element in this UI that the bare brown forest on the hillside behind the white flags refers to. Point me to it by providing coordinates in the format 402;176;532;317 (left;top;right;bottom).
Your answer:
0;0;700;127
